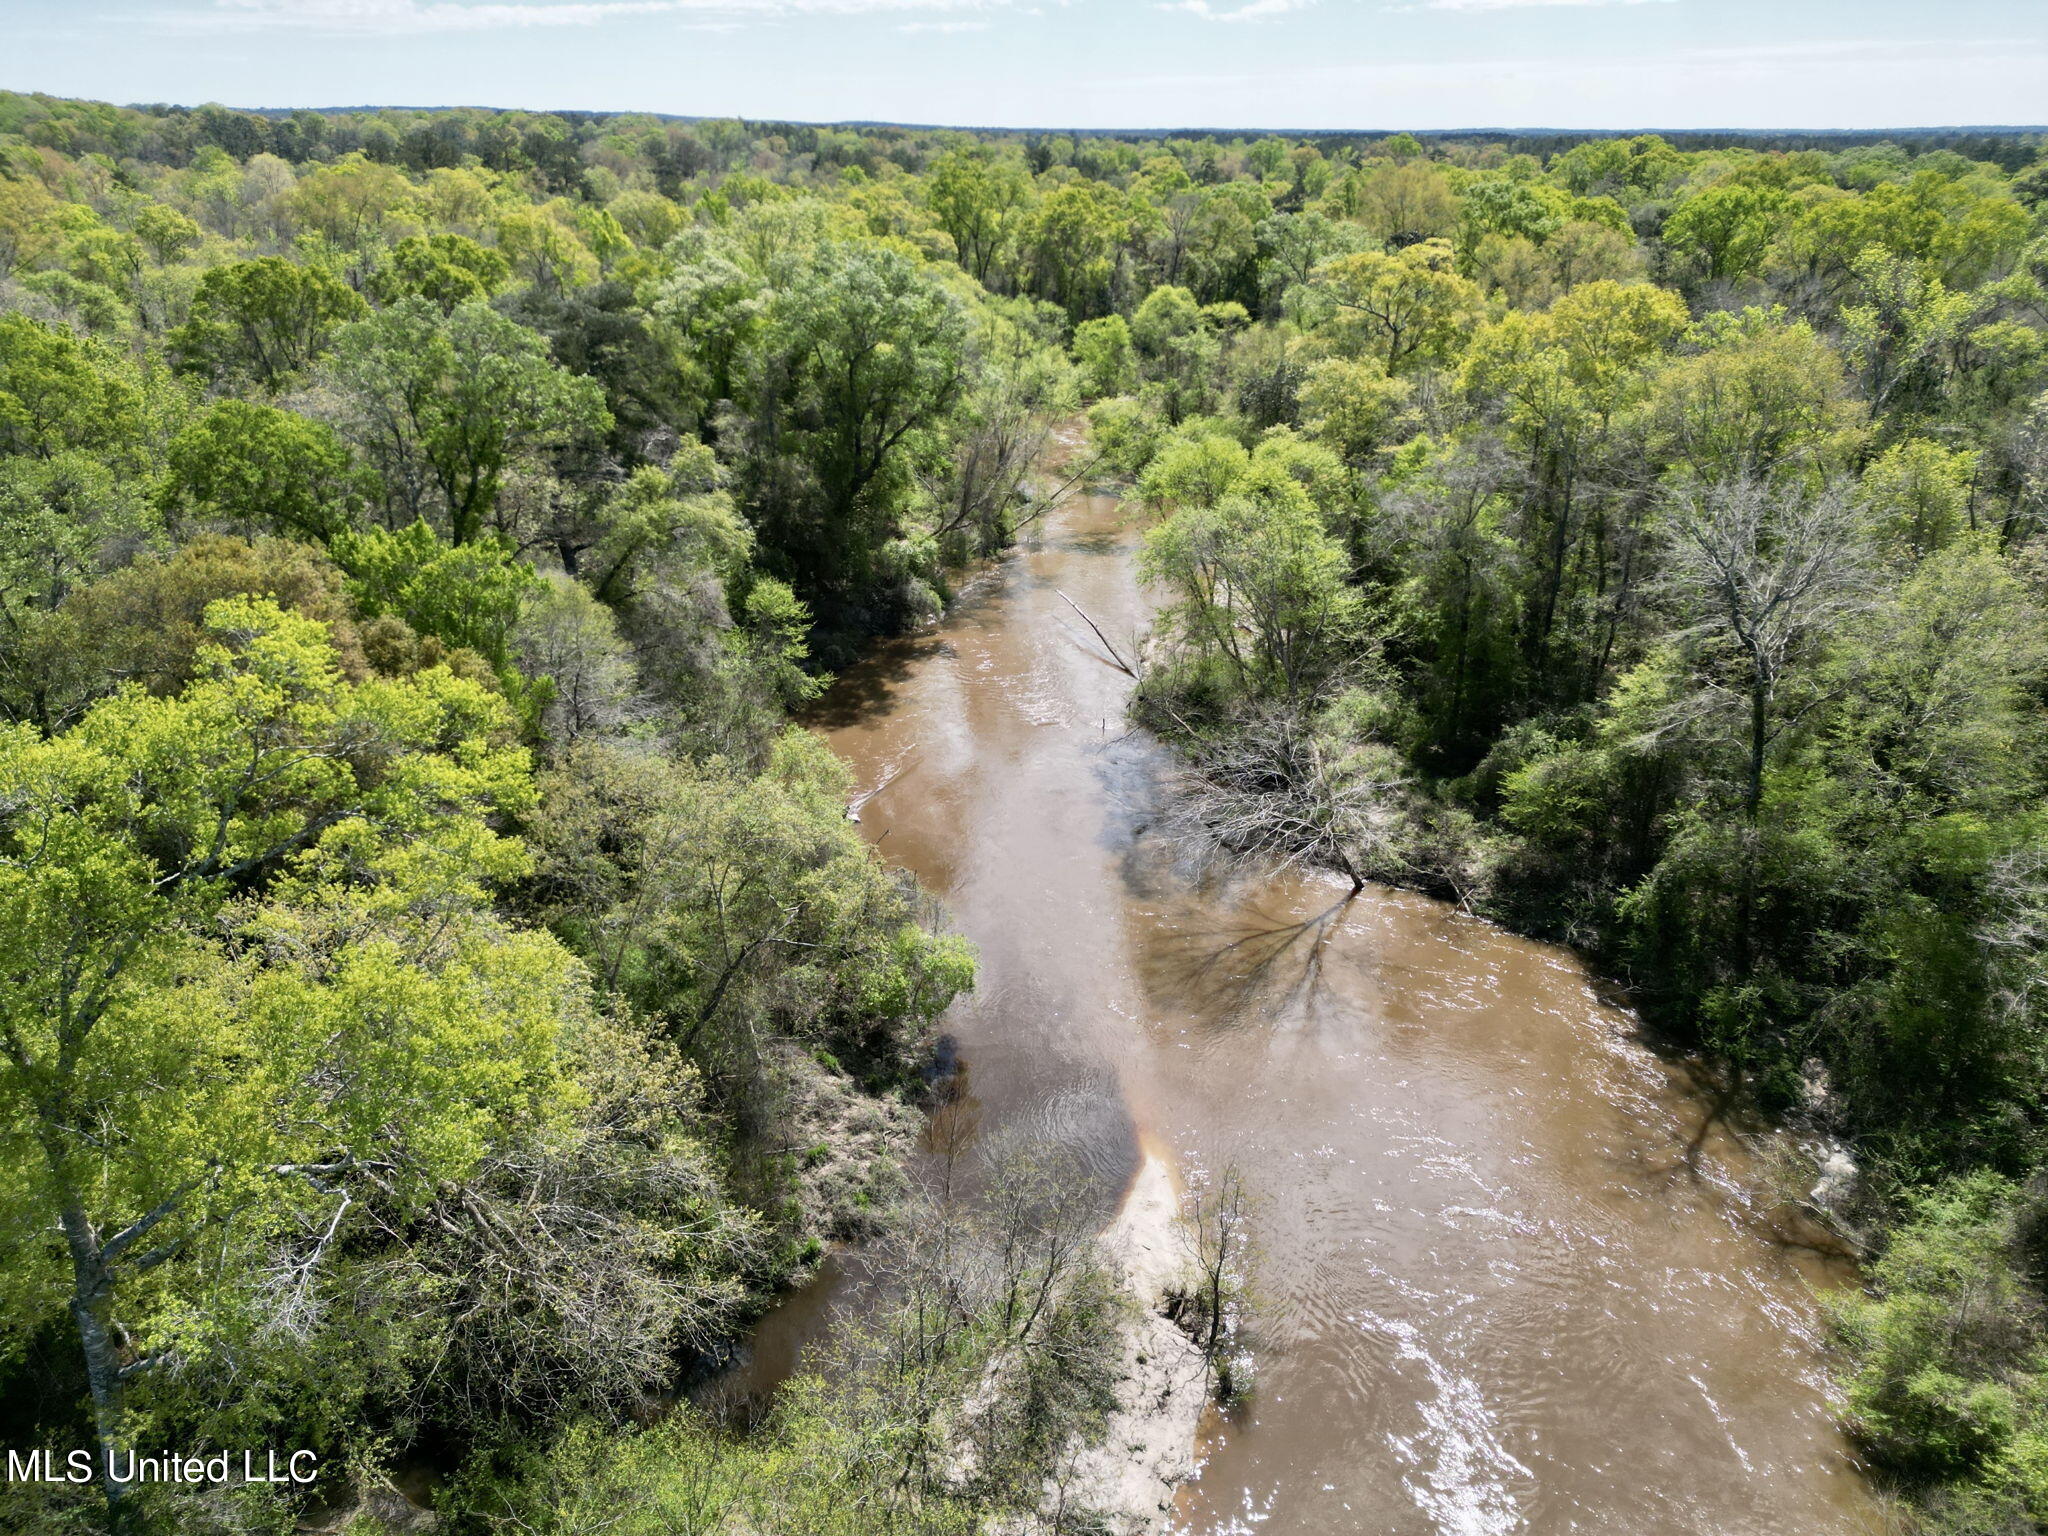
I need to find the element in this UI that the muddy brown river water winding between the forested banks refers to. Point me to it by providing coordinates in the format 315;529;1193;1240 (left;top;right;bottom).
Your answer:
754;428;1882;1536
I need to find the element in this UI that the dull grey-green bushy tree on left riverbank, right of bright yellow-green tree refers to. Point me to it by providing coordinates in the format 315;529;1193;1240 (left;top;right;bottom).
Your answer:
535;731;973;1073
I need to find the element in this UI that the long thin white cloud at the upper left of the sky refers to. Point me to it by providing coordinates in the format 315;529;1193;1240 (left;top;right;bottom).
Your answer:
184;0;1004;37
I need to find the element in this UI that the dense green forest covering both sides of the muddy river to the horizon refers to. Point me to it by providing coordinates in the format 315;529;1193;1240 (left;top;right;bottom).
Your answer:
0;96;2048;1532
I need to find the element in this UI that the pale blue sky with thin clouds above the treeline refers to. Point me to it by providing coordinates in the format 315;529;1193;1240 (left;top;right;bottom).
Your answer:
0;0;2048;129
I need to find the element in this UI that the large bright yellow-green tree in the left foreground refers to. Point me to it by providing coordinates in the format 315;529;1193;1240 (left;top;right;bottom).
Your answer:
0;600;578;1490
